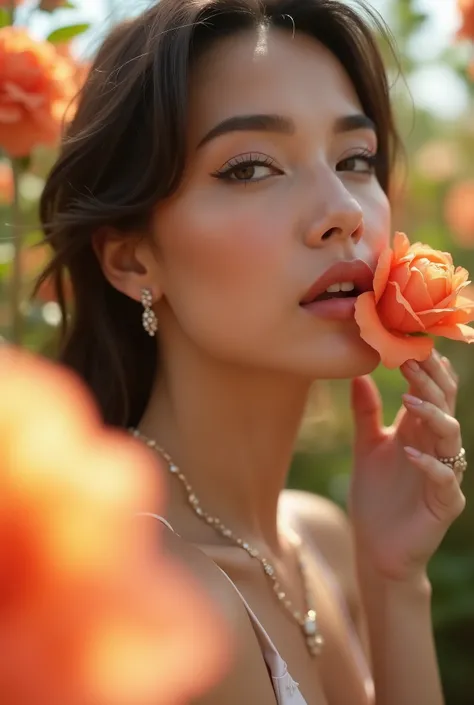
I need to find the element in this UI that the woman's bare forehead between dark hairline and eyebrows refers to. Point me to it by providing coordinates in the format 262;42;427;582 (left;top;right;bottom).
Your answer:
190;29;361;140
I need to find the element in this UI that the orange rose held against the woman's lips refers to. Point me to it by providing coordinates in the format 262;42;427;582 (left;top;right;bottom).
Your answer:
355;233;474;368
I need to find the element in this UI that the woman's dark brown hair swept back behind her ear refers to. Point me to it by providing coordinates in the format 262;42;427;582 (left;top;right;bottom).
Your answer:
36;0;397;426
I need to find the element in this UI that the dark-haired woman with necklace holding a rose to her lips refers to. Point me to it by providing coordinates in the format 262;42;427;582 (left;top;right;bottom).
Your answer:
37;0;464;705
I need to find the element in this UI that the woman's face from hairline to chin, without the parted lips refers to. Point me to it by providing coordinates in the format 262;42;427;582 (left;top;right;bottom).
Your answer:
154;30;390;378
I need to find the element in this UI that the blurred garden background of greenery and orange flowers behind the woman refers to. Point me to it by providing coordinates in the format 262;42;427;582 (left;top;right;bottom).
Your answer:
0;0;474;705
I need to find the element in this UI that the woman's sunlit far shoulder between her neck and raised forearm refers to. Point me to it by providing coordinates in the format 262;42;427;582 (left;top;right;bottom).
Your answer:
280;490;360;619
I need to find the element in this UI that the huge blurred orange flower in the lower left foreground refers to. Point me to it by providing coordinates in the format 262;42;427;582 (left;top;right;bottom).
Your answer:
0;346;229;705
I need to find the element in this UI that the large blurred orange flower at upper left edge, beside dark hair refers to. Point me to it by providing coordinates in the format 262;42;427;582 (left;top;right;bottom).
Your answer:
0;27;77;157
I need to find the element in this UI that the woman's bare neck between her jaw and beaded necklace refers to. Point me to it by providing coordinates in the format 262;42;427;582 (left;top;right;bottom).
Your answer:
139;344;310;553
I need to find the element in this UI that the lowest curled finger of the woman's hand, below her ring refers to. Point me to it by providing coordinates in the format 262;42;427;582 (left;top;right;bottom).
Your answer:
405;446;466;522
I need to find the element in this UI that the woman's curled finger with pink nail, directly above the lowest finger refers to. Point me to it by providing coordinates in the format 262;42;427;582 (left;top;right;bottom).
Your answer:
403;394;462;458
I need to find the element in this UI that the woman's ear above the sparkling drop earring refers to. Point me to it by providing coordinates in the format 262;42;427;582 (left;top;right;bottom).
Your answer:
92;228;162;301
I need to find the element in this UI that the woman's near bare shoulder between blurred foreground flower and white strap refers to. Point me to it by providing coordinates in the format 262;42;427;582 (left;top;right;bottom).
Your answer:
164;531;275;705
